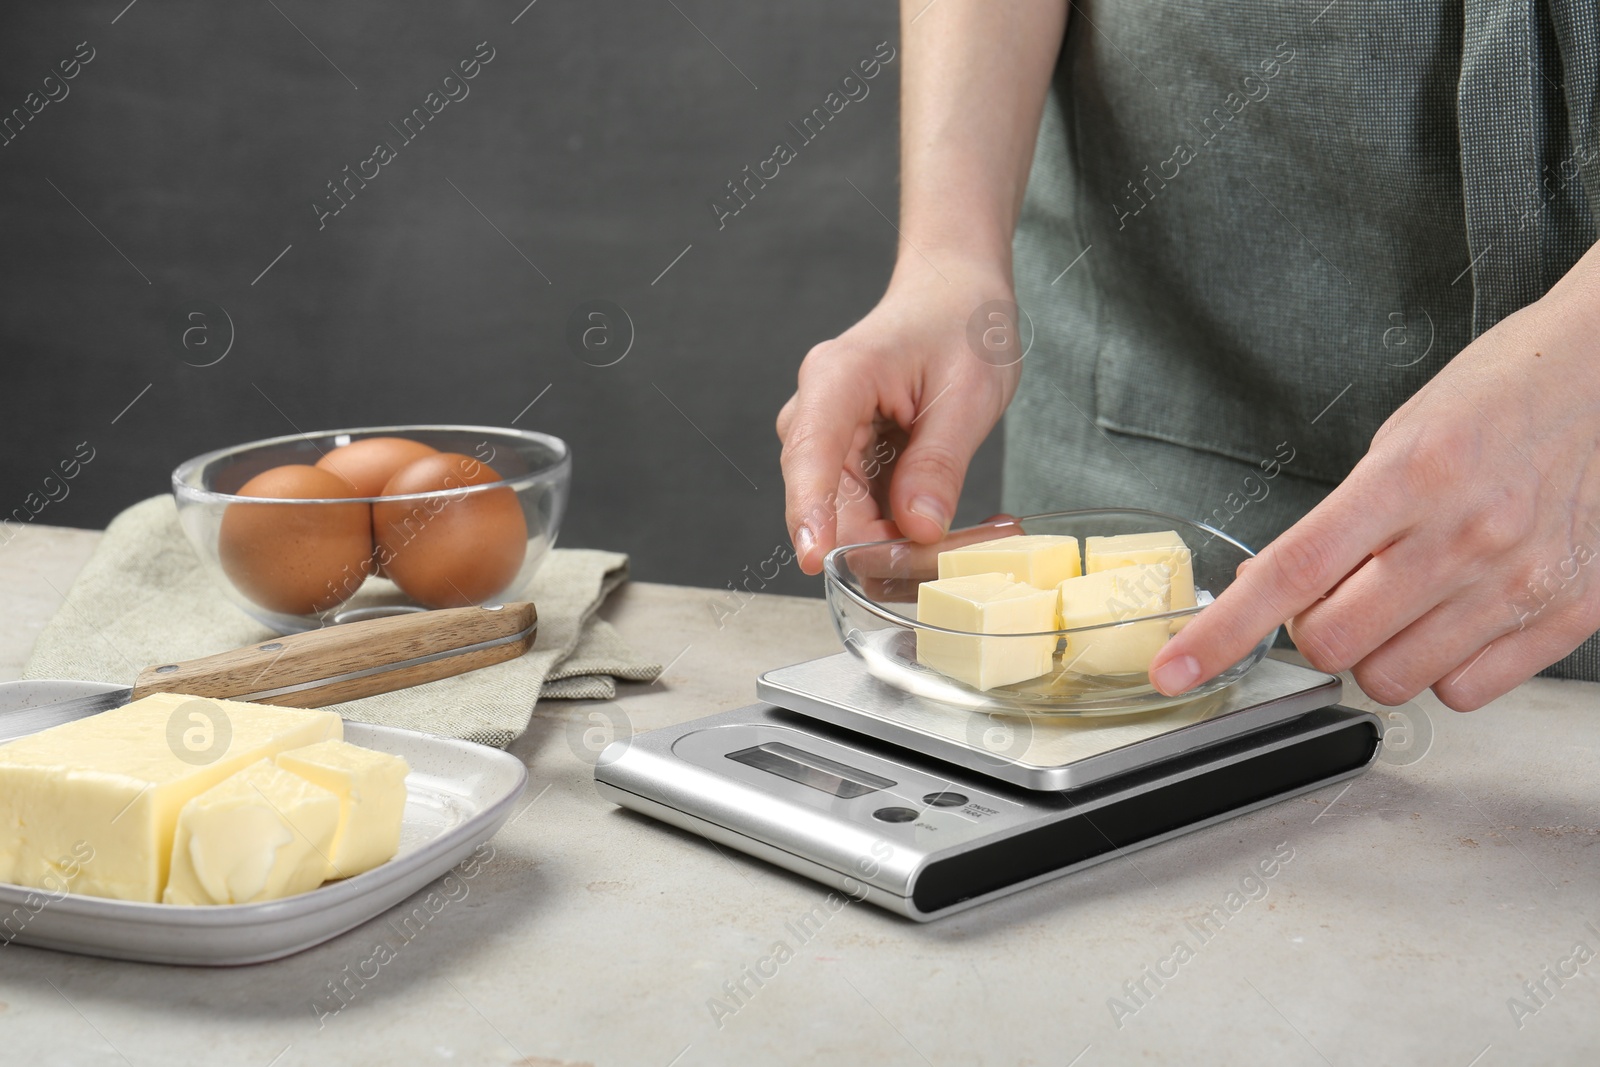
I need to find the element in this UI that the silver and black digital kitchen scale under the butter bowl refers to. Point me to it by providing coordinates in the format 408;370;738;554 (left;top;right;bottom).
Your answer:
595;653;1382;921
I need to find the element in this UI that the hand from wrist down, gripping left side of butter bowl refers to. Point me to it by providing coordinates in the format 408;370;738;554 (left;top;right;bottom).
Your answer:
778;257;1022;574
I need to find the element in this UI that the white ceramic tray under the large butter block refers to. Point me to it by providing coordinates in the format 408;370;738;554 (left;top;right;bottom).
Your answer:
0;681;528;966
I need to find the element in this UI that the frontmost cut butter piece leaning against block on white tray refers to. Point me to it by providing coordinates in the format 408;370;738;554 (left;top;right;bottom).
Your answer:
162;760;339;904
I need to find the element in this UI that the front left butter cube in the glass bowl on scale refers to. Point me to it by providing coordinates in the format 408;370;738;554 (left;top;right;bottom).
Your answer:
917;574;1056;689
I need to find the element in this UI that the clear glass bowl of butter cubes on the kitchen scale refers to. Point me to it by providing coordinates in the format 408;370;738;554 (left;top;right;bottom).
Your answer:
822;509;1277;715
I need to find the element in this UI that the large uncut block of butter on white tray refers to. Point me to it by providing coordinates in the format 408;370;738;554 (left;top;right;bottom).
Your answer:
0;693;344;904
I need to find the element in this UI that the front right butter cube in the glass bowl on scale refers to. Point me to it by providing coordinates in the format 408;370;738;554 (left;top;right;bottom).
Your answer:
1059;563;1173;675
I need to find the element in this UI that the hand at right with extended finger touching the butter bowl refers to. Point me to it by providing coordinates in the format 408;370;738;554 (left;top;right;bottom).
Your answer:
1150;246;1600;712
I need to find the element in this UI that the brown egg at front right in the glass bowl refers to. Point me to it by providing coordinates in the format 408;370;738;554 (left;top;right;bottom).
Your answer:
373;453;528;608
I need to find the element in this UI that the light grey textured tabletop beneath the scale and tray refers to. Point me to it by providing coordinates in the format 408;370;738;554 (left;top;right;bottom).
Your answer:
0;528;1600;1067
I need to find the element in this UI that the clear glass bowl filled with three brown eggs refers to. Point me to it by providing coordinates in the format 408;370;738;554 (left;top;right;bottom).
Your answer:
173;426;573;633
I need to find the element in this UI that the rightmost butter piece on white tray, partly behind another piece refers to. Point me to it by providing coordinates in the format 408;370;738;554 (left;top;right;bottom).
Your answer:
277;741;411;878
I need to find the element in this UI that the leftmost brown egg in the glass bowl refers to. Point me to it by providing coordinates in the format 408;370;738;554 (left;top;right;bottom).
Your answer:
216;464;373;614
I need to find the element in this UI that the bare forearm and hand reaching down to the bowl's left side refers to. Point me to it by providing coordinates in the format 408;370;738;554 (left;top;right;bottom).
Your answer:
778;0;1067;574
